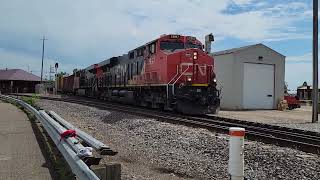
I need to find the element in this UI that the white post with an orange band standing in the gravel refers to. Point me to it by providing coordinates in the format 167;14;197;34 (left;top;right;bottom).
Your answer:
228;127;245;180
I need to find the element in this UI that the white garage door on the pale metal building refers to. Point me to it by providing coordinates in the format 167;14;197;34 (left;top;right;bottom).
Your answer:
243;63;274;109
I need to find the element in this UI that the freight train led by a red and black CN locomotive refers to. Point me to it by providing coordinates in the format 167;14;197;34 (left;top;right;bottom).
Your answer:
61;34;220;114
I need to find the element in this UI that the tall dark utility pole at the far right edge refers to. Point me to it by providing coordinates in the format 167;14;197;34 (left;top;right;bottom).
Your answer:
312;0;319;123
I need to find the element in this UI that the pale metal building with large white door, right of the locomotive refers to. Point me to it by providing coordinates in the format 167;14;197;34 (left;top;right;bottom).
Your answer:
212;44;285;110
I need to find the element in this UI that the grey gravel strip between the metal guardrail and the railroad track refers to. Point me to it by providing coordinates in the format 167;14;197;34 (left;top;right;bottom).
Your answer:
38;100;320;180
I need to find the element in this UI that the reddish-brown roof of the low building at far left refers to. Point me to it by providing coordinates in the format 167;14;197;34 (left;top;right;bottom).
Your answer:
0;69;40;82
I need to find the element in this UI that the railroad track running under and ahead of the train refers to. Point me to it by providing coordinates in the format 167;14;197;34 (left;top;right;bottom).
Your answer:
14;93;320;154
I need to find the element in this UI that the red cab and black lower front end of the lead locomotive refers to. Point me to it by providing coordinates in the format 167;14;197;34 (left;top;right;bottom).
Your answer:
143;35;220;113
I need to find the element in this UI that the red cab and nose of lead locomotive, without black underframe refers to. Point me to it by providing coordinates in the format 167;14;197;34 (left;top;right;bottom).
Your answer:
153;35;214;86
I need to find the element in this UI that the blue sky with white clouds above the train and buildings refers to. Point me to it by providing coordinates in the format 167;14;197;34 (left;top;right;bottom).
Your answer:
0;0;312;89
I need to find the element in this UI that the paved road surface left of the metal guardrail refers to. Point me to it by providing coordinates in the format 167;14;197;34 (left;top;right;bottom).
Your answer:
0;101;52;180
